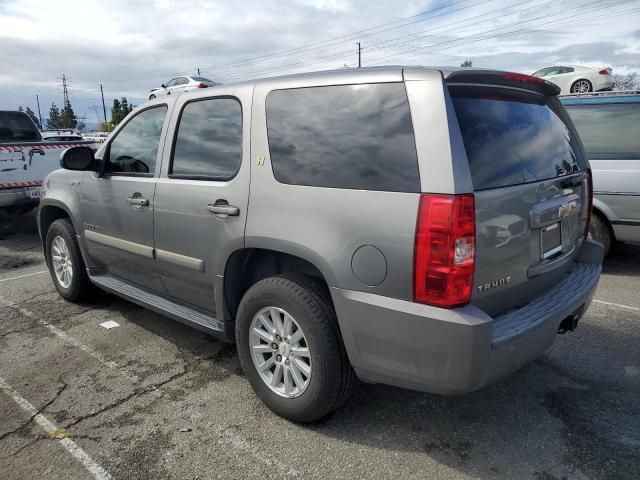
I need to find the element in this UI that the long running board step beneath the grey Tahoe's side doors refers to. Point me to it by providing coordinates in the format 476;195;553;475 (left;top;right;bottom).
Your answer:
89;274;234;342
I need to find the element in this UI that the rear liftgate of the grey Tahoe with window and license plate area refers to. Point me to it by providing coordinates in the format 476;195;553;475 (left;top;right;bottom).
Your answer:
449;75;588;315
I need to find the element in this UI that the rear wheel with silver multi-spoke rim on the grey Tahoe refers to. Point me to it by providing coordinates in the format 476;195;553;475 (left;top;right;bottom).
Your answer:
236;275;356;423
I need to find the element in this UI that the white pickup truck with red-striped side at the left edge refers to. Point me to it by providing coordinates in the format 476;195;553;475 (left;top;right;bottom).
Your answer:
0;111;95;213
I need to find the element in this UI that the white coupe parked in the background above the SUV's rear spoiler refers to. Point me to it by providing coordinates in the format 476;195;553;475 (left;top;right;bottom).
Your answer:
532;65;615;95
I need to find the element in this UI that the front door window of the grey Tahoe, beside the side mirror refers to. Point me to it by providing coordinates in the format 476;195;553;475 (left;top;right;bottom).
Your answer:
105;105;167;175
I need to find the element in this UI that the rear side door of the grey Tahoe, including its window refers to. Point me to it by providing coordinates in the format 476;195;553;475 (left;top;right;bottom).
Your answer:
155;87;251;315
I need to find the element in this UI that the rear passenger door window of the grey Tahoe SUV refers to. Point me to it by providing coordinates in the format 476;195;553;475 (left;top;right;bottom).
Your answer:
169;98;242;180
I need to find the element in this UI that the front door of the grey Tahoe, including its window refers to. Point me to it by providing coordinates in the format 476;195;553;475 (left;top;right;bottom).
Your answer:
81;105;167;291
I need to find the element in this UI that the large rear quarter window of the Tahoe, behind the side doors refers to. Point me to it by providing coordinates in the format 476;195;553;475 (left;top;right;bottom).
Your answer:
267;83;420;192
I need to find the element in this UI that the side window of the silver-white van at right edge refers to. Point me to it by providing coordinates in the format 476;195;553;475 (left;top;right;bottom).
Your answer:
567;103;640;159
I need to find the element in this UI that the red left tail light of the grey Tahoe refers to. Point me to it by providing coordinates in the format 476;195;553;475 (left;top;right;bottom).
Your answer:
413;194;476;308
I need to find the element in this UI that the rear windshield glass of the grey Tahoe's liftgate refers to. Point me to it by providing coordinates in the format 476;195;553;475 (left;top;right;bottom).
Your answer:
450;87;586;190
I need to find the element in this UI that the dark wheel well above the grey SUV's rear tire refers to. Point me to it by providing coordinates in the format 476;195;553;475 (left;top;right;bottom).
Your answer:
224;248;329;318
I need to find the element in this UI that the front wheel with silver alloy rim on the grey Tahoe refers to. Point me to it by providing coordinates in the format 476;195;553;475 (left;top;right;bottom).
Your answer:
45;218;93;302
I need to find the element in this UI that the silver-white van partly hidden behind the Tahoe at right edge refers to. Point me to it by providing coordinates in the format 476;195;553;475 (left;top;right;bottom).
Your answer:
561;92;640;252
